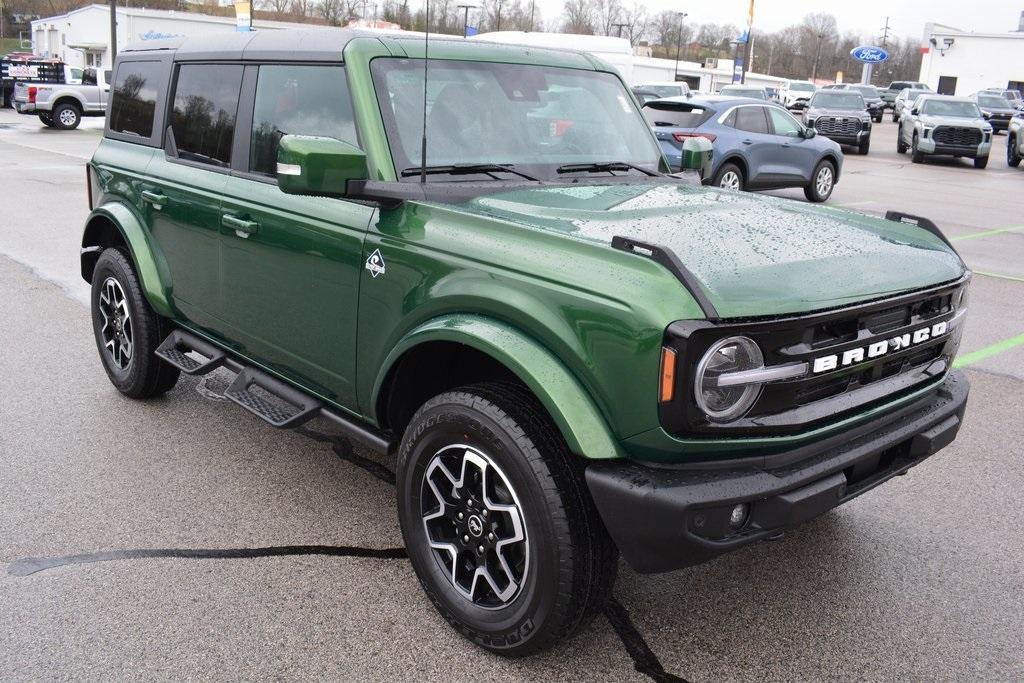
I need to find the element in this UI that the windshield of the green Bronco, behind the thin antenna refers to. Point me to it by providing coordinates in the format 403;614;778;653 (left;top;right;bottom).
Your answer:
371;58;662;182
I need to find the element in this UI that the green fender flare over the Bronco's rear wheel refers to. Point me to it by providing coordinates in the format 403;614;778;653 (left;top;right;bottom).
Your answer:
82;202;175;317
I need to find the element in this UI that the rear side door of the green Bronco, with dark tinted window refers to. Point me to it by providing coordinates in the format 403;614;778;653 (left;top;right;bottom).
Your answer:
142;63;243;336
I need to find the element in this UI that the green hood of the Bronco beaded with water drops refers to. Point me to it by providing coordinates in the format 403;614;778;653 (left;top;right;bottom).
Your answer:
449;182;965;317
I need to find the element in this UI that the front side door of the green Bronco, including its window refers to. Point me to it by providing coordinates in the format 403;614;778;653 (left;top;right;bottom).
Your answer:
220;65;376;407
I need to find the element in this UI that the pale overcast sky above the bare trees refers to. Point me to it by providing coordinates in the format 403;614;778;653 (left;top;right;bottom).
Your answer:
512;0;1024;38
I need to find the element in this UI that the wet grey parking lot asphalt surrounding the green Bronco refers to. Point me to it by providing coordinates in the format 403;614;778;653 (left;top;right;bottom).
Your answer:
6;110;1024;681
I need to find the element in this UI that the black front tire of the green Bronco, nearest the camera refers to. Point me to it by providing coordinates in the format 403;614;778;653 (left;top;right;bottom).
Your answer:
397;383;617;656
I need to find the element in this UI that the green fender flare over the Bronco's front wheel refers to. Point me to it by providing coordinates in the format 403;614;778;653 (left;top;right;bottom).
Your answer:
370;313;625;459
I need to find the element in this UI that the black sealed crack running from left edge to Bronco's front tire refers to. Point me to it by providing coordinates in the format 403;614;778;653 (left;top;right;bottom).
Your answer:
7;546;408;577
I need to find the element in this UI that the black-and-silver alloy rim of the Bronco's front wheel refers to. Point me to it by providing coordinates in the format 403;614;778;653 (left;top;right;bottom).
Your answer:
420;444;529;609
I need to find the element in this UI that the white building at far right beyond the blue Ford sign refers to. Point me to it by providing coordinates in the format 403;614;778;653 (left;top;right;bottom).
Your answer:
919;14;1024;95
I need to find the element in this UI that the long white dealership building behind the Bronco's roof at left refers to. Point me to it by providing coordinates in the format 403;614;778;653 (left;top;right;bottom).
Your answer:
32;5;309;69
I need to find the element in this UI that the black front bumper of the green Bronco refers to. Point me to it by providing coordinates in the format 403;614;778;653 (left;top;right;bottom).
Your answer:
587;371;970;573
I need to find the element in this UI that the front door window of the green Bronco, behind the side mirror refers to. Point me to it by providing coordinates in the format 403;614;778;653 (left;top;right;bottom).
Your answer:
249;65;357;176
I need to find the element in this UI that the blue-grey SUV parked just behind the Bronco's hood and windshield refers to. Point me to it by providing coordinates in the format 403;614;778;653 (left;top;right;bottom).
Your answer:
643;95;843;202
